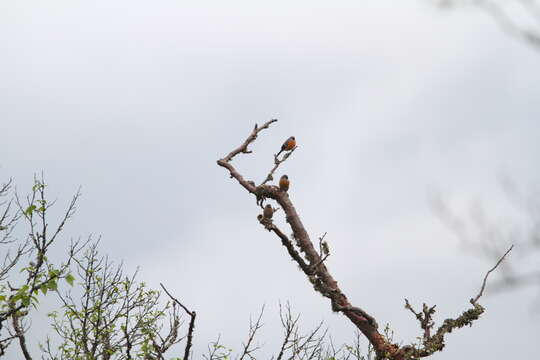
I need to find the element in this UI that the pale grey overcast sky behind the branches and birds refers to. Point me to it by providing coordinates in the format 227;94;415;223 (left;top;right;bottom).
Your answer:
0;0;540;360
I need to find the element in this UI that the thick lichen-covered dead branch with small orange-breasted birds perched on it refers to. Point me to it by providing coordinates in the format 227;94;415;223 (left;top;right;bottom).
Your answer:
217;120;511;360
